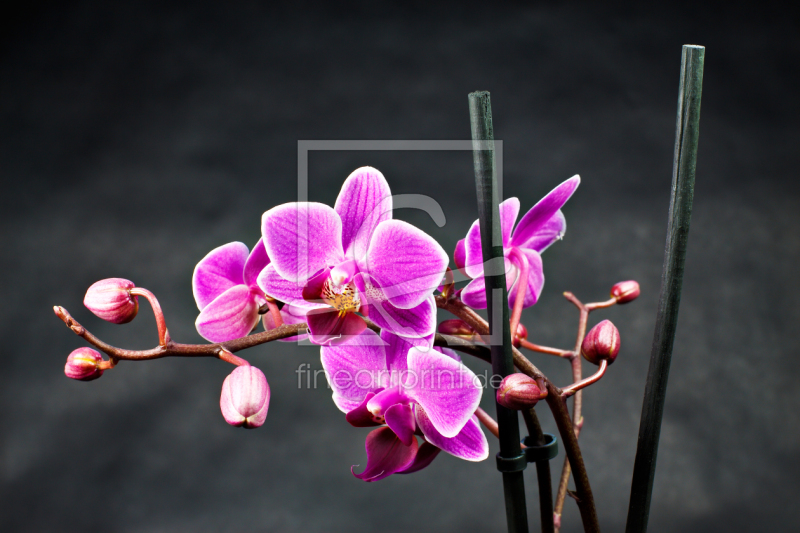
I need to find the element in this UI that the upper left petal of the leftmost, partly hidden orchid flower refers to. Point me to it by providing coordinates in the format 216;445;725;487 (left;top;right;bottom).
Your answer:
192;242;250;311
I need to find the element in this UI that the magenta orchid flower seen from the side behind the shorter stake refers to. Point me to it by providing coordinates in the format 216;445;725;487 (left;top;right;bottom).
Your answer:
455;175;581;309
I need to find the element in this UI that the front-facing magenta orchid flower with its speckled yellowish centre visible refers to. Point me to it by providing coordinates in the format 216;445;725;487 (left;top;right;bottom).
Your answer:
258;167;448;345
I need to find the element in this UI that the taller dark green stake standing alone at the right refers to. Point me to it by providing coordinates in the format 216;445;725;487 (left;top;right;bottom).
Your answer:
625;45;706;533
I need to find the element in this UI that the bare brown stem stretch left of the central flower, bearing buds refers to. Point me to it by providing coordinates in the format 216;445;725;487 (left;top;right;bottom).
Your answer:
53;306;307;361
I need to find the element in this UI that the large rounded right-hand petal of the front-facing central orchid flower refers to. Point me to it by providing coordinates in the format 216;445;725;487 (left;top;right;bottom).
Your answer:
359;220;450;309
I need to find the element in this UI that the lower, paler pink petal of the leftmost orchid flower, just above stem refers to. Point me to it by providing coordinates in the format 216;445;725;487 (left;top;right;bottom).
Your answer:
195;285;258;342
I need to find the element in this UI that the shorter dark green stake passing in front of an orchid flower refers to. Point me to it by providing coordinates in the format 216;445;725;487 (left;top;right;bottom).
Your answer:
469;91;528;533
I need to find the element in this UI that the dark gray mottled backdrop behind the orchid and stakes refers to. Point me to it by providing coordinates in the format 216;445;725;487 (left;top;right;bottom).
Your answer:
0;1;800;532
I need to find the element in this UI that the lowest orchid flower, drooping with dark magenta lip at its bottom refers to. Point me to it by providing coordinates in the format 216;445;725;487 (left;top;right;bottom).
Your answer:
321;330;489;481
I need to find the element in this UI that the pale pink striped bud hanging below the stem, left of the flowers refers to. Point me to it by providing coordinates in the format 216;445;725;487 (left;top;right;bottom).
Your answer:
219;365;269;429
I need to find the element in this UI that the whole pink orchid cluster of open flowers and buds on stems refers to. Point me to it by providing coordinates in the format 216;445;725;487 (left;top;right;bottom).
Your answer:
59;167;639;481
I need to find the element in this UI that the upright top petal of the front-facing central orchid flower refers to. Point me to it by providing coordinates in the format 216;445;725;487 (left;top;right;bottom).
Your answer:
334;167;392;258
